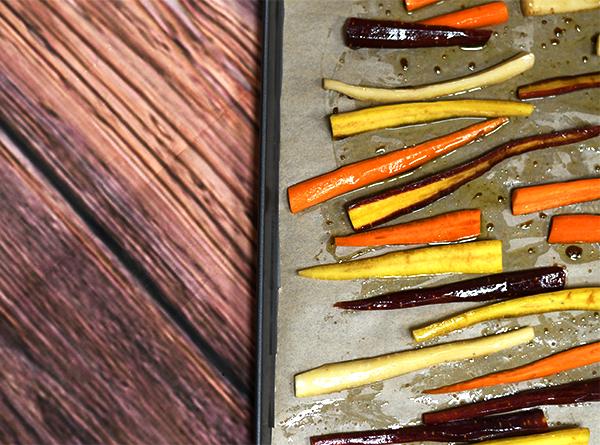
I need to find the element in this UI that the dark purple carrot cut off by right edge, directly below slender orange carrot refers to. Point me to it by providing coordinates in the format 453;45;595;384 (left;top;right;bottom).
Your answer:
423;378;600;424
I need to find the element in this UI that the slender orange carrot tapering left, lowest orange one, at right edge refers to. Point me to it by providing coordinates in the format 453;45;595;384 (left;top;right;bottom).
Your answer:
425;342;600;394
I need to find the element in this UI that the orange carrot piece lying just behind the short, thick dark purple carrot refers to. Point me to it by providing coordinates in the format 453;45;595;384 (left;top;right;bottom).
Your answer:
418;2;508;29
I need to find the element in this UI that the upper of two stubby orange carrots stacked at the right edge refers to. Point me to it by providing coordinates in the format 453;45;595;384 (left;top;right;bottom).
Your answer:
512;178;600;215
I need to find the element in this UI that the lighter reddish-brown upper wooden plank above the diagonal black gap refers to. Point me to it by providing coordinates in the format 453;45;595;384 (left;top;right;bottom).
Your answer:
0;0;259;391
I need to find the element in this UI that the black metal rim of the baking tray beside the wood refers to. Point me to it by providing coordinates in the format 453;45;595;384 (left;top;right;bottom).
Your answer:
254;0;283;445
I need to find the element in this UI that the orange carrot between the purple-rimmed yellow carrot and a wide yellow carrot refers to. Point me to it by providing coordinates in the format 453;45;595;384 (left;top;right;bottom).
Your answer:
335;210;481;247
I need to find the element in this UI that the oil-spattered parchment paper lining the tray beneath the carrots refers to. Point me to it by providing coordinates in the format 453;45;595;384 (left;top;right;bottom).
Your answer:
273;0;600;444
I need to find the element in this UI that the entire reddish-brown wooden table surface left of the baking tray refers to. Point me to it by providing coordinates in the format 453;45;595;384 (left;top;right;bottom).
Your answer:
0;0;260;445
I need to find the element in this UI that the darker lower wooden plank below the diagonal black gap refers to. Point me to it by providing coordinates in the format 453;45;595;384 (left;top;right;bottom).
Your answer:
0;133;250;445
